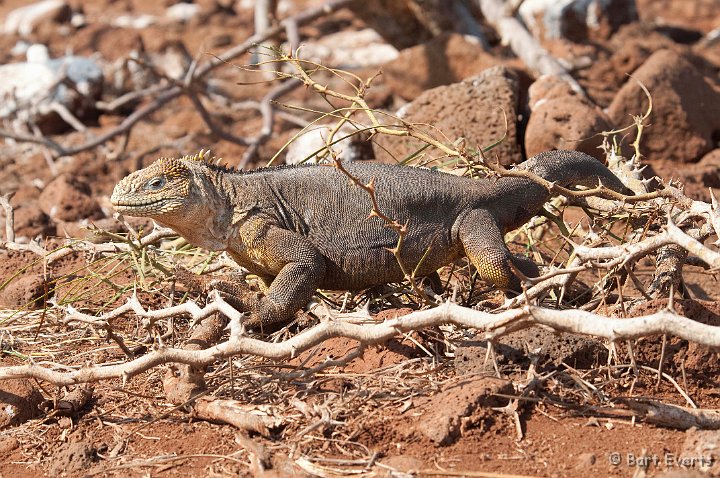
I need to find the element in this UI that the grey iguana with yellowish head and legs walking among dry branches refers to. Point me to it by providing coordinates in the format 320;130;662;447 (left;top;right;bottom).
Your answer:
111;151;626;325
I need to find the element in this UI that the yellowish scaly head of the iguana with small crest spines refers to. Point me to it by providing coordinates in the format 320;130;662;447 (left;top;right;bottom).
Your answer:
110;151;208;222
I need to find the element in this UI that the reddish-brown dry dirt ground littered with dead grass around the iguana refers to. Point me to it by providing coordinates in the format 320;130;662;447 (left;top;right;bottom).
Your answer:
0;0;720;477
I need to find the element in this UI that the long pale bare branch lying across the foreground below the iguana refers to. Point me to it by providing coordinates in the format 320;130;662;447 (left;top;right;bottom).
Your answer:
0;294;720;385
